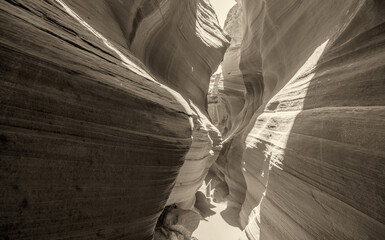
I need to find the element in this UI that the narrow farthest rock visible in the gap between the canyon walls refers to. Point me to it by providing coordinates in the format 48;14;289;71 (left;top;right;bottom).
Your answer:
208;4;246;215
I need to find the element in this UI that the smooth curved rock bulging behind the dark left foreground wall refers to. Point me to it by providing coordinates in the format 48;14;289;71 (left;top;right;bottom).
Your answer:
111;0;229;209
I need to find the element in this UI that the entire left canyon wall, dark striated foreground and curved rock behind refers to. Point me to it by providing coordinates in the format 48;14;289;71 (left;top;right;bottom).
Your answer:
0;0;227;239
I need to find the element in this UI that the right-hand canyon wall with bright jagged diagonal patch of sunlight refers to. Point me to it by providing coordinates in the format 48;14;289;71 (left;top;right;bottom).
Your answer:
210;0;385;239
